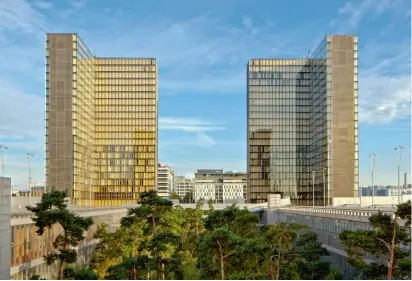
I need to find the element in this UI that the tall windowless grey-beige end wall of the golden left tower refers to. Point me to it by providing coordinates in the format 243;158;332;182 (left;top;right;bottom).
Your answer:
46;34;74;198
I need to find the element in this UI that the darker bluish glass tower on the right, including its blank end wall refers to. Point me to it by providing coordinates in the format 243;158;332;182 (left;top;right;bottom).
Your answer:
247;35;358;206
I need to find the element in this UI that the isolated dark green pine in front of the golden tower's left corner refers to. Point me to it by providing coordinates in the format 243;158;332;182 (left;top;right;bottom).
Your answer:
26;190;93;280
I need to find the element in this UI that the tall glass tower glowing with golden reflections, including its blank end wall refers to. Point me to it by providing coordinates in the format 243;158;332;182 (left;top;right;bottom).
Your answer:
45;33;158;206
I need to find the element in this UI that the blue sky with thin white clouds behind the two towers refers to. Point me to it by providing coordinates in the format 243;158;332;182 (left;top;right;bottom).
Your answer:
0;0;411;189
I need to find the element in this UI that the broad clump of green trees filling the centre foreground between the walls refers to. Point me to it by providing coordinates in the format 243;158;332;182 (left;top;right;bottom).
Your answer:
90;192;341;280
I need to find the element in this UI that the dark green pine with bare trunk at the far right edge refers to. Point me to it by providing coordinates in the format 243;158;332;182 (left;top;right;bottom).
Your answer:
339;201;411;280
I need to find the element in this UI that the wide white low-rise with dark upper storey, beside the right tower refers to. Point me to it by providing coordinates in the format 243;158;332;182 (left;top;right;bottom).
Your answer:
194;170;247;203
